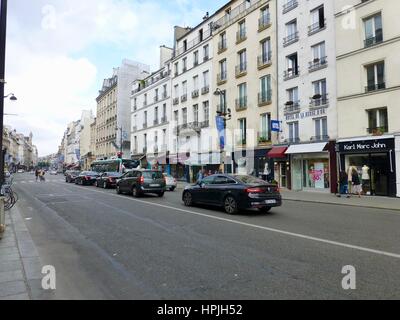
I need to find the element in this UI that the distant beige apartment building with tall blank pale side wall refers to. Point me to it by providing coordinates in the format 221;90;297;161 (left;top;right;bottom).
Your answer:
96;59;150;159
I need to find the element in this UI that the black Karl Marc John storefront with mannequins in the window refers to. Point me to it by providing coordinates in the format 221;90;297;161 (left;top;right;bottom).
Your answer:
337;136;396;197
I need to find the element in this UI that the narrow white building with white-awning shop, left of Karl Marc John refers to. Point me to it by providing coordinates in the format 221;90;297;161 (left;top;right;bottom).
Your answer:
274;0;337;192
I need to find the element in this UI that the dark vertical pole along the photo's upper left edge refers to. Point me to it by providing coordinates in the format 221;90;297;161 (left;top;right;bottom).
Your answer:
0;0;7;186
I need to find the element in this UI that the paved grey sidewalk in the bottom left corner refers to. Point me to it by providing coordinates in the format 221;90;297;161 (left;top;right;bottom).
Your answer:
0;208;42;300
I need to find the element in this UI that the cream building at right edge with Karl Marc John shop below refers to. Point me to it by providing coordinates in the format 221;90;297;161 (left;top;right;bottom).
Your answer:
335;0;400;196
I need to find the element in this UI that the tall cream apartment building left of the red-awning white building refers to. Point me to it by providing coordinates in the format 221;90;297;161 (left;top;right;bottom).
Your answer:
212;0;278;175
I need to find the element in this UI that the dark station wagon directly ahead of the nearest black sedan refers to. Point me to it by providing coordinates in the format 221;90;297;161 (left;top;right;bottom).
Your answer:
117;170;166;198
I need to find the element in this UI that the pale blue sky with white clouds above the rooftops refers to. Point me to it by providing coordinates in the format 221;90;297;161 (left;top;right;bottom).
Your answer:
4;0;227;156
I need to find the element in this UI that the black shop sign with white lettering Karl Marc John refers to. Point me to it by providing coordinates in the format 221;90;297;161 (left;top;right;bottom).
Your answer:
338;138;394;152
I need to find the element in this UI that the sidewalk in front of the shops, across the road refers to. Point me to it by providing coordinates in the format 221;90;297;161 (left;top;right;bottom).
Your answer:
177;182;400;213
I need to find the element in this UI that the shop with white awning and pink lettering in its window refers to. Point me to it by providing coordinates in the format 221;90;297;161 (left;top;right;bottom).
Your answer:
285;142;337;193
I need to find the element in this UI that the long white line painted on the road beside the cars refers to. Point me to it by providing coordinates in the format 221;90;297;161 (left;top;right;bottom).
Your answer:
54;181;400;259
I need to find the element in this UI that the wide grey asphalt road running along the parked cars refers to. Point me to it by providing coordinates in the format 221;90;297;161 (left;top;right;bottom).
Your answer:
8;174;400;299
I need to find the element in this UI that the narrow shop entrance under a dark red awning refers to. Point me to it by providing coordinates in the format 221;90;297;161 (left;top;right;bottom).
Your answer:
268;146;291;189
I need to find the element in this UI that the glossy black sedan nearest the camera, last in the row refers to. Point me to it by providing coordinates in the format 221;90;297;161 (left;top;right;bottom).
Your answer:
182;175;282;214
